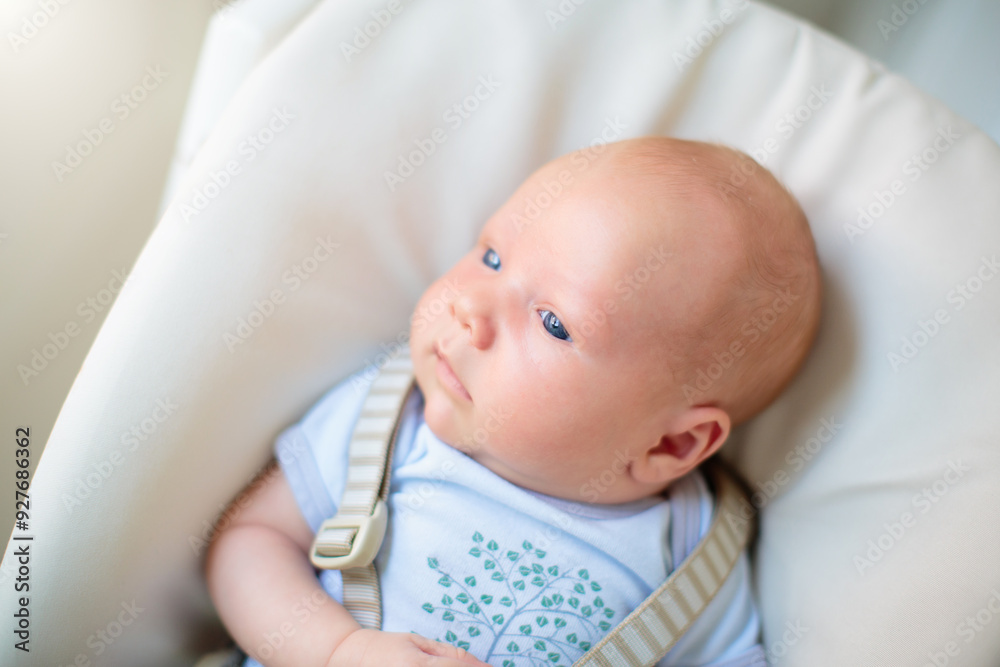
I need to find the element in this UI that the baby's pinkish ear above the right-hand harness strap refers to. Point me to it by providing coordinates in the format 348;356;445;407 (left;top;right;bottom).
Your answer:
632;405;731;484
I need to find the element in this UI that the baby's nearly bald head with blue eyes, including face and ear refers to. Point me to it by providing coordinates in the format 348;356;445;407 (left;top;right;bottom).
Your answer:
410;137;821;503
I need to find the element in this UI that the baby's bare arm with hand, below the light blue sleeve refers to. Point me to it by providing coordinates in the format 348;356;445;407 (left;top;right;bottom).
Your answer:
205;466;485;667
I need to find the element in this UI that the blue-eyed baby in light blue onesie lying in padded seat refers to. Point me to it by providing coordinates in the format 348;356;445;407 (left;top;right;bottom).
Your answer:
206;137;821;667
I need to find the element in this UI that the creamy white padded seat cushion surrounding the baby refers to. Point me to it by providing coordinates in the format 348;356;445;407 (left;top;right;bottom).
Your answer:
7;0;1000;666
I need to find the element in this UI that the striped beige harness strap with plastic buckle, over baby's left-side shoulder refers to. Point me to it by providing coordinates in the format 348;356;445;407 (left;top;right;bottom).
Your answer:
304;348;415;629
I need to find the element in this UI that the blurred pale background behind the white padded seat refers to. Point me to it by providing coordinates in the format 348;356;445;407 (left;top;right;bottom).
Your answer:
0;0;1000;540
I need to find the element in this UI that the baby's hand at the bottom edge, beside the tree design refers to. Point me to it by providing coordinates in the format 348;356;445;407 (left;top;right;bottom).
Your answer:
327;630;489;667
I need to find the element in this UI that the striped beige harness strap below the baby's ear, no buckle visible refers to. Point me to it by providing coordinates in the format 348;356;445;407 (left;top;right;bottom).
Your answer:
574;464;754;667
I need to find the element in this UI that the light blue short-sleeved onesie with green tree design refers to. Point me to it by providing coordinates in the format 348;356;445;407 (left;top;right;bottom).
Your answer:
246;379;766;667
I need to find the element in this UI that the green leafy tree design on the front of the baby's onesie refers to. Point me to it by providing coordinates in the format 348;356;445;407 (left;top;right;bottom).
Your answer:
421;531;615;667
